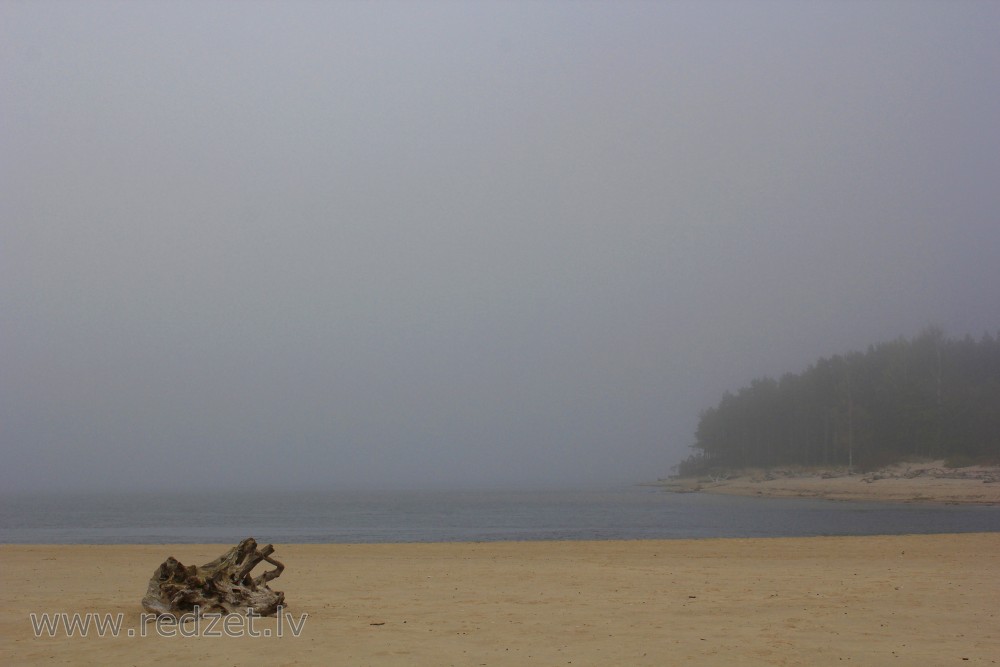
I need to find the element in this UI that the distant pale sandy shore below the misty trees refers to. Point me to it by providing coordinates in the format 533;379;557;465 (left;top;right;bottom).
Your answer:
661;461;1000;505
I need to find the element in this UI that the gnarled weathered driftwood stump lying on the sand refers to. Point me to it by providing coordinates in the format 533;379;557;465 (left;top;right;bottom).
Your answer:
142;537;285;618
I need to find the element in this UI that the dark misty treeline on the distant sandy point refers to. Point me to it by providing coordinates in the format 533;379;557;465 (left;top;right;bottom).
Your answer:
678;328;1000;475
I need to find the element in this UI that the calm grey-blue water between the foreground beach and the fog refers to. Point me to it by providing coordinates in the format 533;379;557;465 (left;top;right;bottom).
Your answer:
0;487;1000;544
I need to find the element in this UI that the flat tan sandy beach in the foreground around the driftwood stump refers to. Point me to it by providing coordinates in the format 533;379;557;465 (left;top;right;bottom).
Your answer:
0;533;1000;667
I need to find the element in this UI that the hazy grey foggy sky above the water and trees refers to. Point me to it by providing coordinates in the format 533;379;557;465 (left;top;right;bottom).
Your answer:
0;0;1000;489
